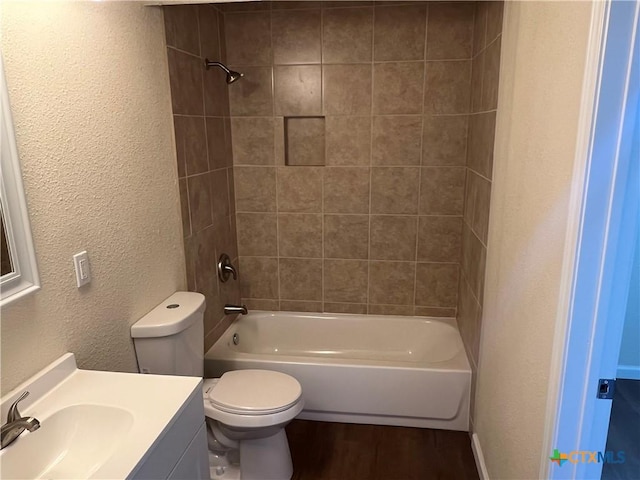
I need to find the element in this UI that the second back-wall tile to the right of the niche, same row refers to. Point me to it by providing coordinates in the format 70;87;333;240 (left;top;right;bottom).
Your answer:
371;115;422;165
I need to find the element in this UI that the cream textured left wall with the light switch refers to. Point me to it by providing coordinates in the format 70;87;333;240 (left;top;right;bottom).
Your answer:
1;2;185;392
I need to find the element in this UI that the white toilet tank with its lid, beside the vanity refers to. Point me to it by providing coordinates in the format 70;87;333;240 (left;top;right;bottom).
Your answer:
131;292;206;377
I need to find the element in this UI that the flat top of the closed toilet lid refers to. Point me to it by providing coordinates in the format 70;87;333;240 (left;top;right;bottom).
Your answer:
209;370;302;415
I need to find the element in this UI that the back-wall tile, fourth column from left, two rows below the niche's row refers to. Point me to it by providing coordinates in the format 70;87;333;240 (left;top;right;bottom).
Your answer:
370;215;418;261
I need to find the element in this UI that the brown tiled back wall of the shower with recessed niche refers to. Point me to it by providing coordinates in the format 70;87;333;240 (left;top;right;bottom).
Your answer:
223;2;475;316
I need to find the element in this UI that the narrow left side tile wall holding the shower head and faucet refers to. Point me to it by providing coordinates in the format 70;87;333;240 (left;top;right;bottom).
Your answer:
164;5;240;349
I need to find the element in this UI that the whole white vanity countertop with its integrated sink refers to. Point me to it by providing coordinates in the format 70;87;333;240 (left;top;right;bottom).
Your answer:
0;354;206;480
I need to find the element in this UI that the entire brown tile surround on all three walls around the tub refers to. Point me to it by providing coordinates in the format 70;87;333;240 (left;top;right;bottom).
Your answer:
165;2;502;360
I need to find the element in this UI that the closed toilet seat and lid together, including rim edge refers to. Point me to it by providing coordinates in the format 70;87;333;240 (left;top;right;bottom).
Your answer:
202;370;304;428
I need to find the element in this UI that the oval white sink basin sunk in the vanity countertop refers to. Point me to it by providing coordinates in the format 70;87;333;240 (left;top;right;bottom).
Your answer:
2;405;134;479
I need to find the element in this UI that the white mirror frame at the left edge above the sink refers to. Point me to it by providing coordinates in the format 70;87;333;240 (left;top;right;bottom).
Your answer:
0;55;40;307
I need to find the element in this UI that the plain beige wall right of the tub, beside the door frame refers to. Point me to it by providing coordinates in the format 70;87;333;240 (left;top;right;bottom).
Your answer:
475;2;591;479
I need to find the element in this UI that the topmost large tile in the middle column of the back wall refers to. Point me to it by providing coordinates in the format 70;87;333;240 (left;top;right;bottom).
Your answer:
322;7;373;63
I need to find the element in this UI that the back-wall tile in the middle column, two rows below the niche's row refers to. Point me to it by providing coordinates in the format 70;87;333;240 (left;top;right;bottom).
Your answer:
324;215;369;259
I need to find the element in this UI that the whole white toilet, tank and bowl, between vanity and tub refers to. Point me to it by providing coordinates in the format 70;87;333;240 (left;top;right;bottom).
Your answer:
131;292;304;480
